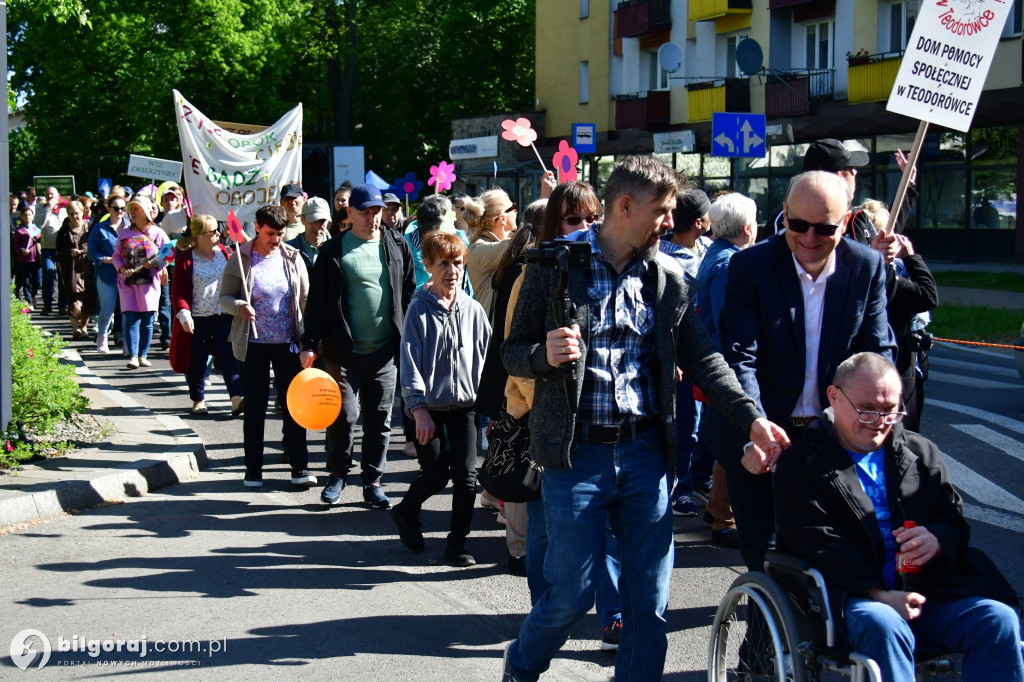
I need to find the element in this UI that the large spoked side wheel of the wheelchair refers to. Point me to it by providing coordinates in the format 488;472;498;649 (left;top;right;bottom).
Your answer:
708;572;808;682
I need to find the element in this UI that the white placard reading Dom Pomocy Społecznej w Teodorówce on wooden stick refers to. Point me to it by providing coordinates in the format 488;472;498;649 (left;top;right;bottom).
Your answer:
886;0;1013;132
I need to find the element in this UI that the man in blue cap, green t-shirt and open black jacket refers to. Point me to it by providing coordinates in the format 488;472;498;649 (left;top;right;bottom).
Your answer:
300;184;416;509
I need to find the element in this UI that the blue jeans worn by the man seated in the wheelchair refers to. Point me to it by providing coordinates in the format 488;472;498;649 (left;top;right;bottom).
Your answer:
843;597;1024;682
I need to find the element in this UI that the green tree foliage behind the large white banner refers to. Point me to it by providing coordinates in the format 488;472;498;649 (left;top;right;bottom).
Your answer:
7;0;534;187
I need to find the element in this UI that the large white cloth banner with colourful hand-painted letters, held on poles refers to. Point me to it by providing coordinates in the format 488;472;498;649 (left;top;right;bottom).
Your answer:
173;90;302;221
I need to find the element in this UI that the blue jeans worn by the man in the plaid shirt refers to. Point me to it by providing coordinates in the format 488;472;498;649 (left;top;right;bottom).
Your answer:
508;429;673;680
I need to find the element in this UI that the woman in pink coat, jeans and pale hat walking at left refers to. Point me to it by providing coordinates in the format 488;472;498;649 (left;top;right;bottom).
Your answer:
112;195;168;370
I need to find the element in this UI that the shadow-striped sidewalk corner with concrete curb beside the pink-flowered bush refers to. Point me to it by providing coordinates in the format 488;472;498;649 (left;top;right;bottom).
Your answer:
0;348;209;530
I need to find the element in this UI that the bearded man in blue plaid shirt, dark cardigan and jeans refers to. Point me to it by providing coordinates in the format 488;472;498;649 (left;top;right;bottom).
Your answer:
502;156;788;682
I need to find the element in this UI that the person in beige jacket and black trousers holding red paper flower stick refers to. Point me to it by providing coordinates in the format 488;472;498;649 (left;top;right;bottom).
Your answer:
220;206;316;487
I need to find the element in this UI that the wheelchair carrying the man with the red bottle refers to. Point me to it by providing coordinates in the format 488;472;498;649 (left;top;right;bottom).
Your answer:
708;552;959;682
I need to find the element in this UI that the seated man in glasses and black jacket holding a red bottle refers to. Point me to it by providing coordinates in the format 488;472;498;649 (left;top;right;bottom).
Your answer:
773;353;1024;682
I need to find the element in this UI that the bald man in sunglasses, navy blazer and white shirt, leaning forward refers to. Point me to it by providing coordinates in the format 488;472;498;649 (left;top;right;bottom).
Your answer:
710;171;896;570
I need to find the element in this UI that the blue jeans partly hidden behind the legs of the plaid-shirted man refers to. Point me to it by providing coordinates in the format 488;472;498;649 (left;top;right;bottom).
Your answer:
526;491;623;628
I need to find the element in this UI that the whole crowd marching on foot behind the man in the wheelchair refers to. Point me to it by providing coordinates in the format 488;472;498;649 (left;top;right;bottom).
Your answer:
10;140;1024;680
